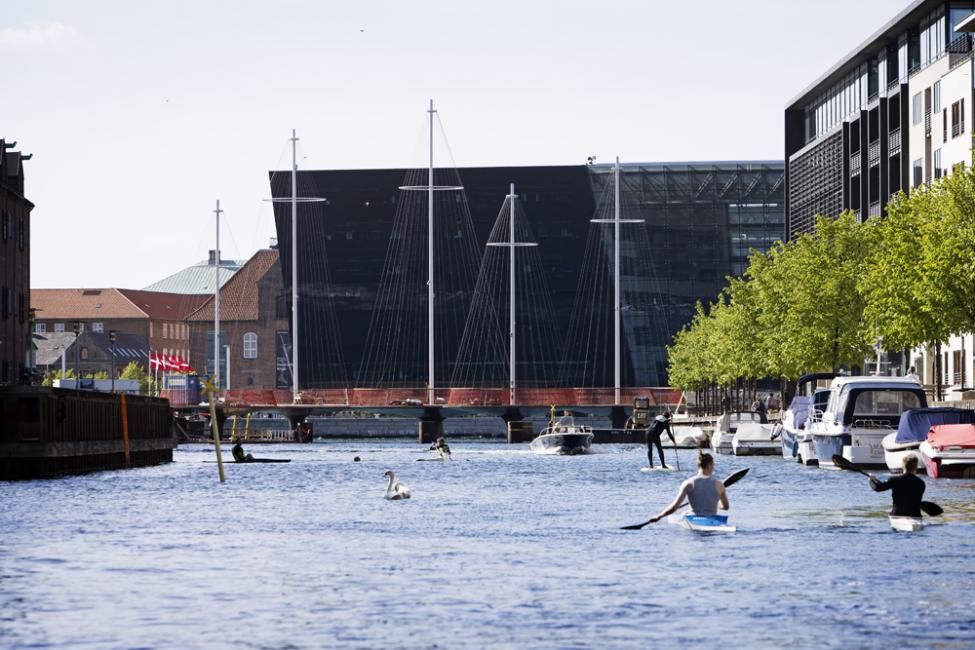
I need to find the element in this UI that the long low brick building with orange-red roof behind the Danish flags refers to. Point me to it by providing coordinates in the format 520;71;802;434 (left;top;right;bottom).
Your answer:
31;289;207;363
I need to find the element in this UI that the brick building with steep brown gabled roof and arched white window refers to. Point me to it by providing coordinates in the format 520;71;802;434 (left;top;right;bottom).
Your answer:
186;249;291;389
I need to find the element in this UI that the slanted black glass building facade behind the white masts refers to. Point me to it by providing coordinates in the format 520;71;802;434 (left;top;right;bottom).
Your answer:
271;161;784;388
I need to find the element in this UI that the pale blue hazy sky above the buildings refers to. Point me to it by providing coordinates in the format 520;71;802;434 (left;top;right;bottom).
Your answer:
0;0;907;289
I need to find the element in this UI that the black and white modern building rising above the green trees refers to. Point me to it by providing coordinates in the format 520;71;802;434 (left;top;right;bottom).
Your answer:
785;0;975;239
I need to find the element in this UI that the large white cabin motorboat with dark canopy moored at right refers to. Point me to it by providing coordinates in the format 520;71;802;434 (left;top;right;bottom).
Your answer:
809;376;928;469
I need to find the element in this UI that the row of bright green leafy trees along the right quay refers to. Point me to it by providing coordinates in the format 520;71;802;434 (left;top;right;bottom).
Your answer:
668;168;975;389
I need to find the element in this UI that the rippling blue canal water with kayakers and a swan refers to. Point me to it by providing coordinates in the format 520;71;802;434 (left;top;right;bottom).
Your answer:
0;439;975;649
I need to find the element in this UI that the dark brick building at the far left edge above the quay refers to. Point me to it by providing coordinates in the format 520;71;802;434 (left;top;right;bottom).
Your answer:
0;139;34;385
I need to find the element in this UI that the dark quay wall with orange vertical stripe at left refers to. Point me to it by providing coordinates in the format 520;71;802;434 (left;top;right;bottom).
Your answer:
0;386;176;480
